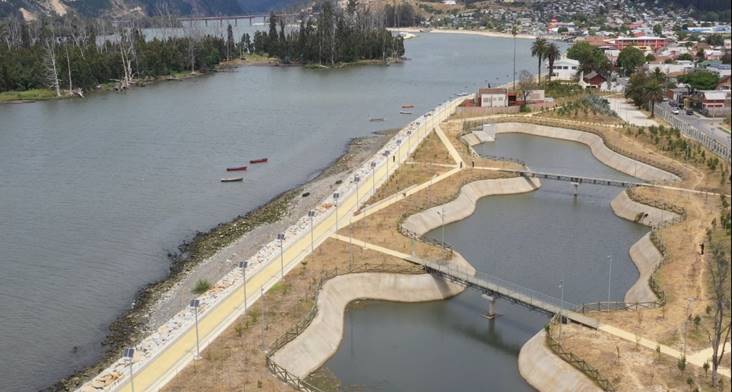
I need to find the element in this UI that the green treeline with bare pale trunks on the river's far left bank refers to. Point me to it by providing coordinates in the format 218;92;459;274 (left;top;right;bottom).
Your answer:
0;20;229;95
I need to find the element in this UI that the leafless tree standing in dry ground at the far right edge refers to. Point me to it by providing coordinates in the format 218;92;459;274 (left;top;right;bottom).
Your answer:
706;244;730;387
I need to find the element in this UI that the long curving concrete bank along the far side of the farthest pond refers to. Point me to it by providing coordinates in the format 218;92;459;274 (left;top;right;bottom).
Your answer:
496;123;680;182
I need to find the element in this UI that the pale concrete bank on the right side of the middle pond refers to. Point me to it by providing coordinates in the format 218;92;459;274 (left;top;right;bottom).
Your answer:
610;191;679;303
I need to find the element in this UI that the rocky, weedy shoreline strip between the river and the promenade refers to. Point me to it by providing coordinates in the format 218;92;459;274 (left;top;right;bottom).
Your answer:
48;130;396;392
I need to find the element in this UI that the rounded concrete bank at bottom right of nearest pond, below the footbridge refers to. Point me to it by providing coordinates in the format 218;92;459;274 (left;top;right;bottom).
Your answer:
518;330;601;392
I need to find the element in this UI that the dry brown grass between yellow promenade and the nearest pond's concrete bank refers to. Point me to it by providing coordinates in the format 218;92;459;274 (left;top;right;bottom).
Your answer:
164;239;419;391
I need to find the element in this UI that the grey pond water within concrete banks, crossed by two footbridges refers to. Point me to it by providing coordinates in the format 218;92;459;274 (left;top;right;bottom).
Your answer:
326;134;646;391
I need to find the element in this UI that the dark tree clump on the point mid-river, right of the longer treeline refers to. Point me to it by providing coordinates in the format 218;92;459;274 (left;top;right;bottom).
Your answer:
250;0;404;65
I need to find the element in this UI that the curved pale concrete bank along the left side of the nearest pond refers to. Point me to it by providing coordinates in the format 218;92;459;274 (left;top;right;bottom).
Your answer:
273;253;475;378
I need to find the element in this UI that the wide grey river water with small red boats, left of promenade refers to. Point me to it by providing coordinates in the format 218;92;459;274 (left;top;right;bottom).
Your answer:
0;34;534;392
